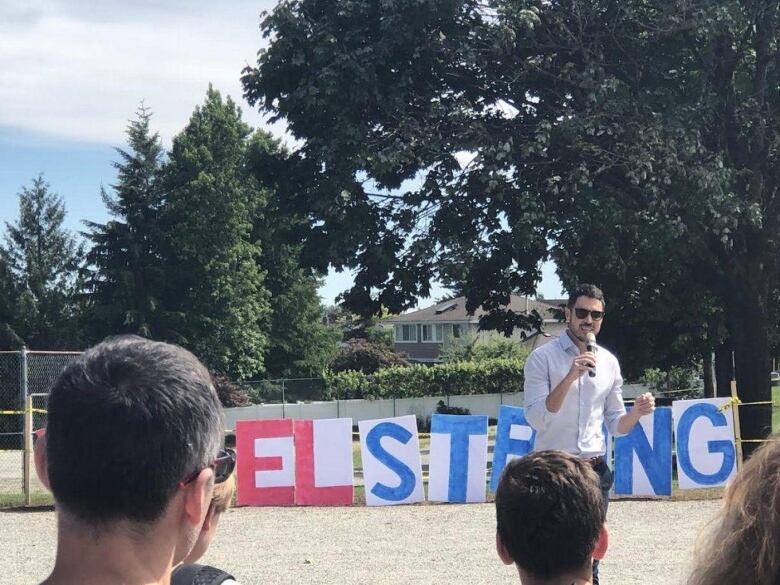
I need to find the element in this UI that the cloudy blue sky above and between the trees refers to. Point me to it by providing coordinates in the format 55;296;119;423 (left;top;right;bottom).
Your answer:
0;0;562;306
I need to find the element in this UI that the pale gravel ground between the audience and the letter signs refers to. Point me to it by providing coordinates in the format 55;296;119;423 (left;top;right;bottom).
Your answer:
0;500;720;585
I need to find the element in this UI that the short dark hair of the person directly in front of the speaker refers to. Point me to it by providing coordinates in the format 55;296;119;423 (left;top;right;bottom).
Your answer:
496;451;606;579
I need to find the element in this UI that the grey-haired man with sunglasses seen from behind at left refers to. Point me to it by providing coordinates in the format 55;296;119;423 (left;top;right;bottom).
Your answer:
35;336;231;585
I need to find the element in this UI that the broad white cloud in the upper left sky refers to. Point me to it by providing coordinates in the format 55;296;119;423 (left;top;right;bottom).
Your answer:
0;0;275;144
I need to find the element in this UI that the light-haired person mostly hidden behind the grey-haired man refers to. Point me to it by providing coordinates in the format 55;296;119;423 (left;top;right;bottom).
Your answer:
171;472;237;585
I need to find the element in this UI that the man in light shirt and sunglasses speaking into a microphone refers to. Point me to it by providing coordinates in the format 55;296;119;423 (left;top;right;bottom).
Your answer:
524;284;655;585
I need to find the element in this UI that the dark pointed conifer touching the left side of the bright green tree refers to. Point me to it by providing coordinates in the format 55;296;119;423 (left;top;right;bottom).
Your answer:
85;105;165;341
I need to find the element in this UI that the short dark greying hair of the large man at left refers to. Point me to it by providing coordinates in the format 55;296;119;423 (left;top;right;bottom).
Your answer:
46;336;222;526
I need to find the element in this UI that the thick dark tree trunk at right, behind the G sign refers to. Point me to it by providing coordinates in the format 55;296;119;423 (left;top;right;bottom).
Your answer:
718;290;772;457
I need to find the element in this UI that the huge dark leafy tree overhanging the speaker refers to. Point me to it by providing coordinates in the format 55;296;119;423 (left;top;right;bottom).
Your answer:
243;0;780;450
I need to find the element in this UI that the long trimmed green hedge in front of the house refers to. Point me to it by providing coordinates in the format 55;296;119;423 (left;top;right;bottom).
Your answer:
324;358;525;400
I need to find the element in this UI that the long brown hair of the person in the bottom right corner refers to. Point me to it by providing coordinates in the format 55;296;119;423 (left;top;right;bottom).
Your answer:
688;435;780;585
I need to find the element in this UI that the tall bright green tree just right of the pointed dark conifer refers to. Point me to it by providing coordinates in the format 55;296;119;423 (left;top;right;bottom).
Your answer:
159;87;269;379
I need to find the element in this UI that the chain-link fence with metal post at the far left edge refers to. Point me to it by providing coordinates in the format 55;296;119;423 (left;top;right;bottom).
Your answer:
0;350;79;503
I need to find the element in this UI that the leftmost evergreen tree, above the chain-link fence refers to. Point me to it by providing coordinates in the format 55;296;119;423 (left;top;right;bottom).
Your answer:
0;175;82;349
